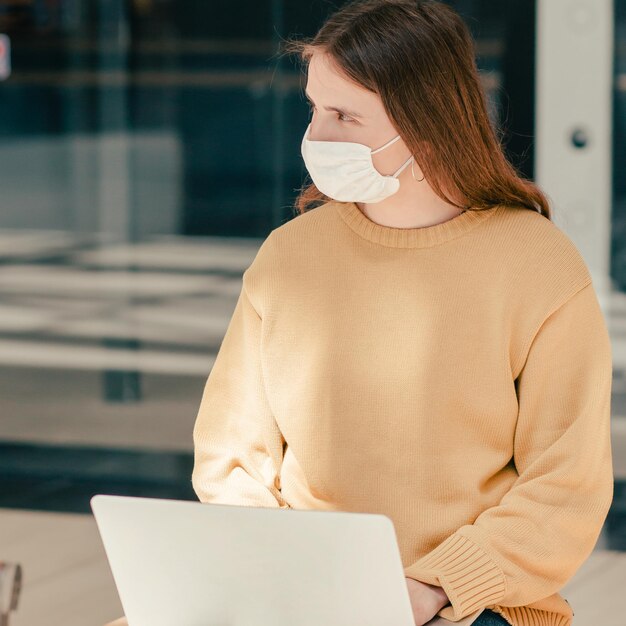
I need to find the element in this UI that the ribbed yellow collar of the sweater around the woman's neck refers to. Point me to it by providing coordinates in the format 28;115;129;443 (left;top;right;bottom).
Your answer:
335;202;504;248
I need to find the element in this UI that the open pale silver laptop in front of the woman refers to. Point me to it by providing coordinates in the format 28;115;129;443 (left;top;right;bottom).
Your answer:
90;494;483;626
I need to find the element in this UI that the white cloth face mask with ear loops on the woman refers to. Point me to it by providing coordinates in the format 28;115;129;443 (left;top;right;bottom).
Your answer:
300;123;413;204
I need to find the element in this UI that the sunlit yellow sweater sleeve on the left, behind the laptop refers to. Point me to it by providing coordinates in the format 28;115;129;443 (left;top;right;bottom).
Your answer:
192;270;291;508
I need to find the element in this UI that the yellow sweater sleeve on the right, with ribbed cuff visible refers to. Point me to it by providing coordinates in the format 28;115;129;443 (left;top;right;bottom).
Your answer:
404;282;613;621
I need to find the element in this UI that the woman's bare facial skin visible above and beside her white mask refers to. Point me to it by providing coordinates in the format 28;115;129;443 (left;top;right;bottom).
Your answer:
305;52;411;175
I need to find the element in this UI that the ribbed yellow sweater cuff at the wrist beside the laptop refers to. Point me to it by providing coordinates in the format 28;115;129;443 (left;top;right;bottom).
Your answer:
404;533;506;621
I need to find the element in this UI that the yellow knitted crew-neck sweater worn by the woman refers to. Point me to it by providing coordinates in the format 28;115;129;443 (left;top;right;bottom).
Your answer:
192;201;613;626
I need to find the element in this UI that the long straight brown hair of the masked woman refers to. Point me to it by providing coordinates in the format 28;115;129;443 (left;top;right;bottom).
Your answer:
282;0;552;219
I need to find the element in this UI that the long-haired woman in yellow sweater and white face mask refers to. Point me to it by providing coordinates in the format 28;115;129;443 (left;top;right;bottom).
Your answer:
192;0;613;626
